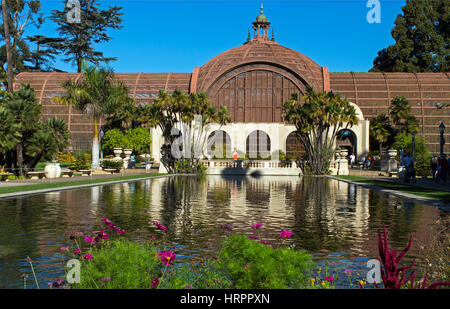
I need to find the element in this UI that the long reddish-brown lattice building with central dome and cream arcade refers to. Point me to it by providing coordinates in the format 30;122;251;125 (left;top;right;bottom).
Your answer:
15;8;450;159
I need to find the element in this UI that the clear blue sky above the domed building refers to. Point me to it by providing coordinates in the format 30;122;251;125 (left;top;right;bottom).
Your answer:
29;0;405;72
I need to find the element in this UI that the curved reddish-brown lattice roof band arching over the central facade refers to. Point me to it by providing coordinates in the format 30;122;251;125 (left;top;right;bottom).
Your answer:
197;38;323;92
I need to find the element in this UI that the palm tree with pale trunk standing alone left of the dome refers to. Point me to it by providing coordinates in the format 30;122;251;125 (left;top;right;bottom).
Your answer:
55;62;132;168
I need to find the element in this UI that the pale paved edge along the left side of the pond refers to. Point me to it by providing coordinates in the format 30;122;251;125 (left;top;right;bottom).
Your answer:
0;174;188;199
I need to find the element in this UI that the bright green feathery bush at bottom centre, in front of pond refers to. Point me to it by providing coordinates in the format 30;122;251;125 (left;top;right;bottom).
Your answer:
218;235;312;289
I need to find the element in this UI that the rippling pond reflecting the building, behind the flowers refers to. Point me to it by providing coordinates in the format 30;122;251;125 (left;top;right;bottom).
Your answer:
0;176;448;288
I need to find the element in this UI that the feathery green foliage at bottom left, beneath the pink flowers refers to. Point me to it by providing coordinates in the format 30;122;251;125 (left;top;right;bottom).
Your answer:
72;239;229;289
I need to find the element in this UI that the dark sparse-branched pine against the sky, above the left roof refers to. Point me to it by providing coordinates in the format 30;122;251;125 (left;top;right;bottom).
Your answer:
51;0;123;72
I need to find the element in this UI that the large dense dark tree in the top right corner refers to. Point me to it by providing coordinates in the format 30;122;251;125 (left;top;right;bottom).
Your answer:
370;0;450;72
